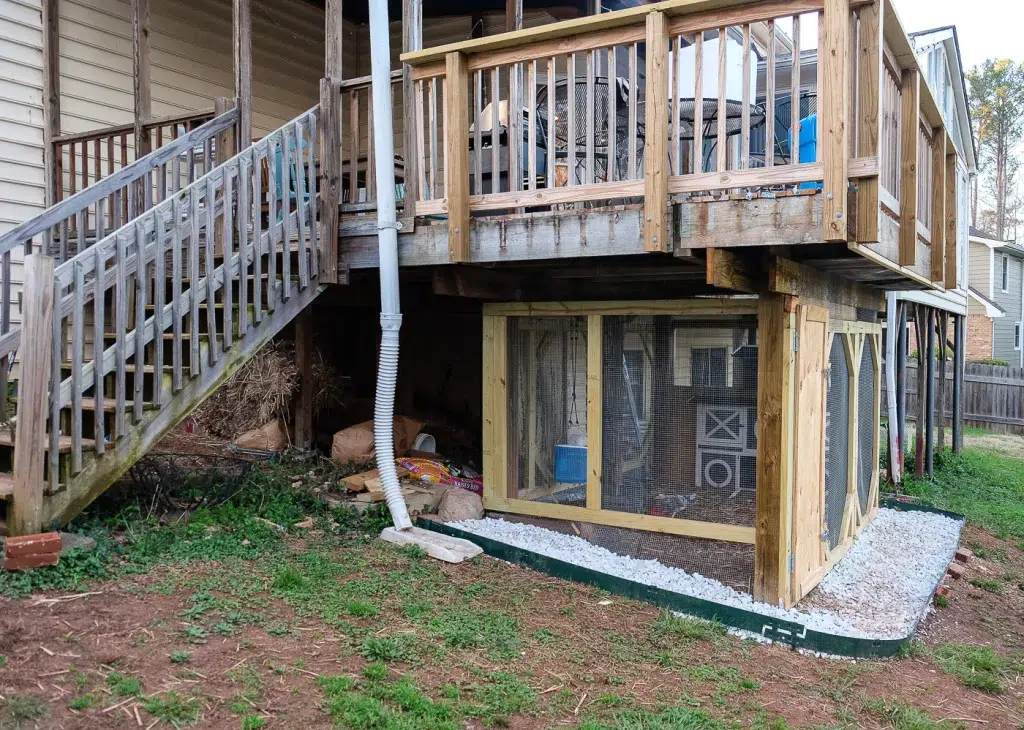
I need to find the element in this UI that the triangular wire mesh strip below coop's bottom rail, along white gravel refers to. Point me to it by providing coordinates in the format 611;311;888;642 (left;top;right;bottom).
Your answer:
488;513;754;593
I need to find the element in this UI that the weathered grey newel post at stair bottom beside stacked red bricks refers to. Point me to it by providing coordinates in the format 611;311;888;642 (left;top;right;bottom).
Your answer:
8;254;56;535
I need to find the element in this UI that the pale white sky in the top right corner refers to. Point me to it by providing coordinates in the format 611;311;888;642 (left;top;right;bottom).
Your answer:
893;0;1024;72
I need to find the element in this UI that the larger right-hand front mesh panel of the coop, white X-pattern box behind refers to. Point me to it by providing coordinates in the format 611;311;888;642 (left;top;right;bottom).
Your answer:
601;315;758;526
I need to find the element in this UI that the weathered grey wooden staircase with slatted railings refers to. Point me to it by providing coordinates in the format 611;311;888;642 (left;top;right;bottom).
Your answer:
0;108;323;534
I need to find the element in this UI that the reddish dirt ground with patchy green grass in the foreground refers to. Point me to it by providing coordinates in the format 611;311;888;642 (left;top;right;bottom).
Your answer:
0;524;1024;730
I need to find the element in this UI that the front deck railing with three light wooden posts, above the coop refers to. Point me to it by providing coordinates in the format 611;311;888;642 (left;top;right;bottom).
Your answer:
402;0;860;260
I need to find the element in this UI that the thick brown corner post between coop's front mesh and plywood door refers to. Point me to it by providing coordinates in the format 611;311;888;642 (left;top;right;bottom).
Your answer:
754;294;798;605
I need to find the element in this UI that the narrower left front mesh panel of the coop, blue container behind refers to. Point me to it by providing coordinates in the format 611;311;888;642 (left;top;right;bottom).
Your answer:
507;316;587;507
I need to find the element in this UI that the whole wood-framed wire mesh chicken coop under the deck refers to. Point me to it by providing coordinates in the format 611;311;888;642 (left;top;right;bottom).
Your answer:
483;297;881;604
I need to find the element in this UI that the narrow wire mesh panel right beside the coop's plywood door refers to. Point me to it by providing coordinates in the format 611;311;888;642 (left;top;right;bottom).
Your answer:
825;335;850;550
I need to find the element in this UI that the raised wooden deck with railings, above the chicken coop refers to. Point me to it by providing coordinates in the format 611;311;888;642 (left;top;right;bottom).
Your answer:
338;0;956;290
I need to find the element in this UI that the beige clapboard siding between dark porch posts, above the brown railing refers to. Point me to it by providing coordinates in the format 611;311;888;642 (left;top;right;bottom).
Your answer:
59;0;331;136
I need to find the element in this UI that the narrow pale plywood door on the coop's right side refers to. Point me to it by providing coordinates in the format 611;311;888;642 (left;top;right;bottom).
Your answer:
792;304;829;601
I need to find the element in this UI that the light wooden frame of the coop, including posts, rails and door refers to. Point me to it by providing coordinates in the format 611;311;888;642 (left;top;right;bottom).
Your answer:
482;294;882;606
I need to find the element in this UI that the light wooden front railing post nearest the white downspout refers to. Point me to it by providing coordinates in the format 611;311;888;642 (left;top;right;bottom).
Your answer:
444;53;469;263
